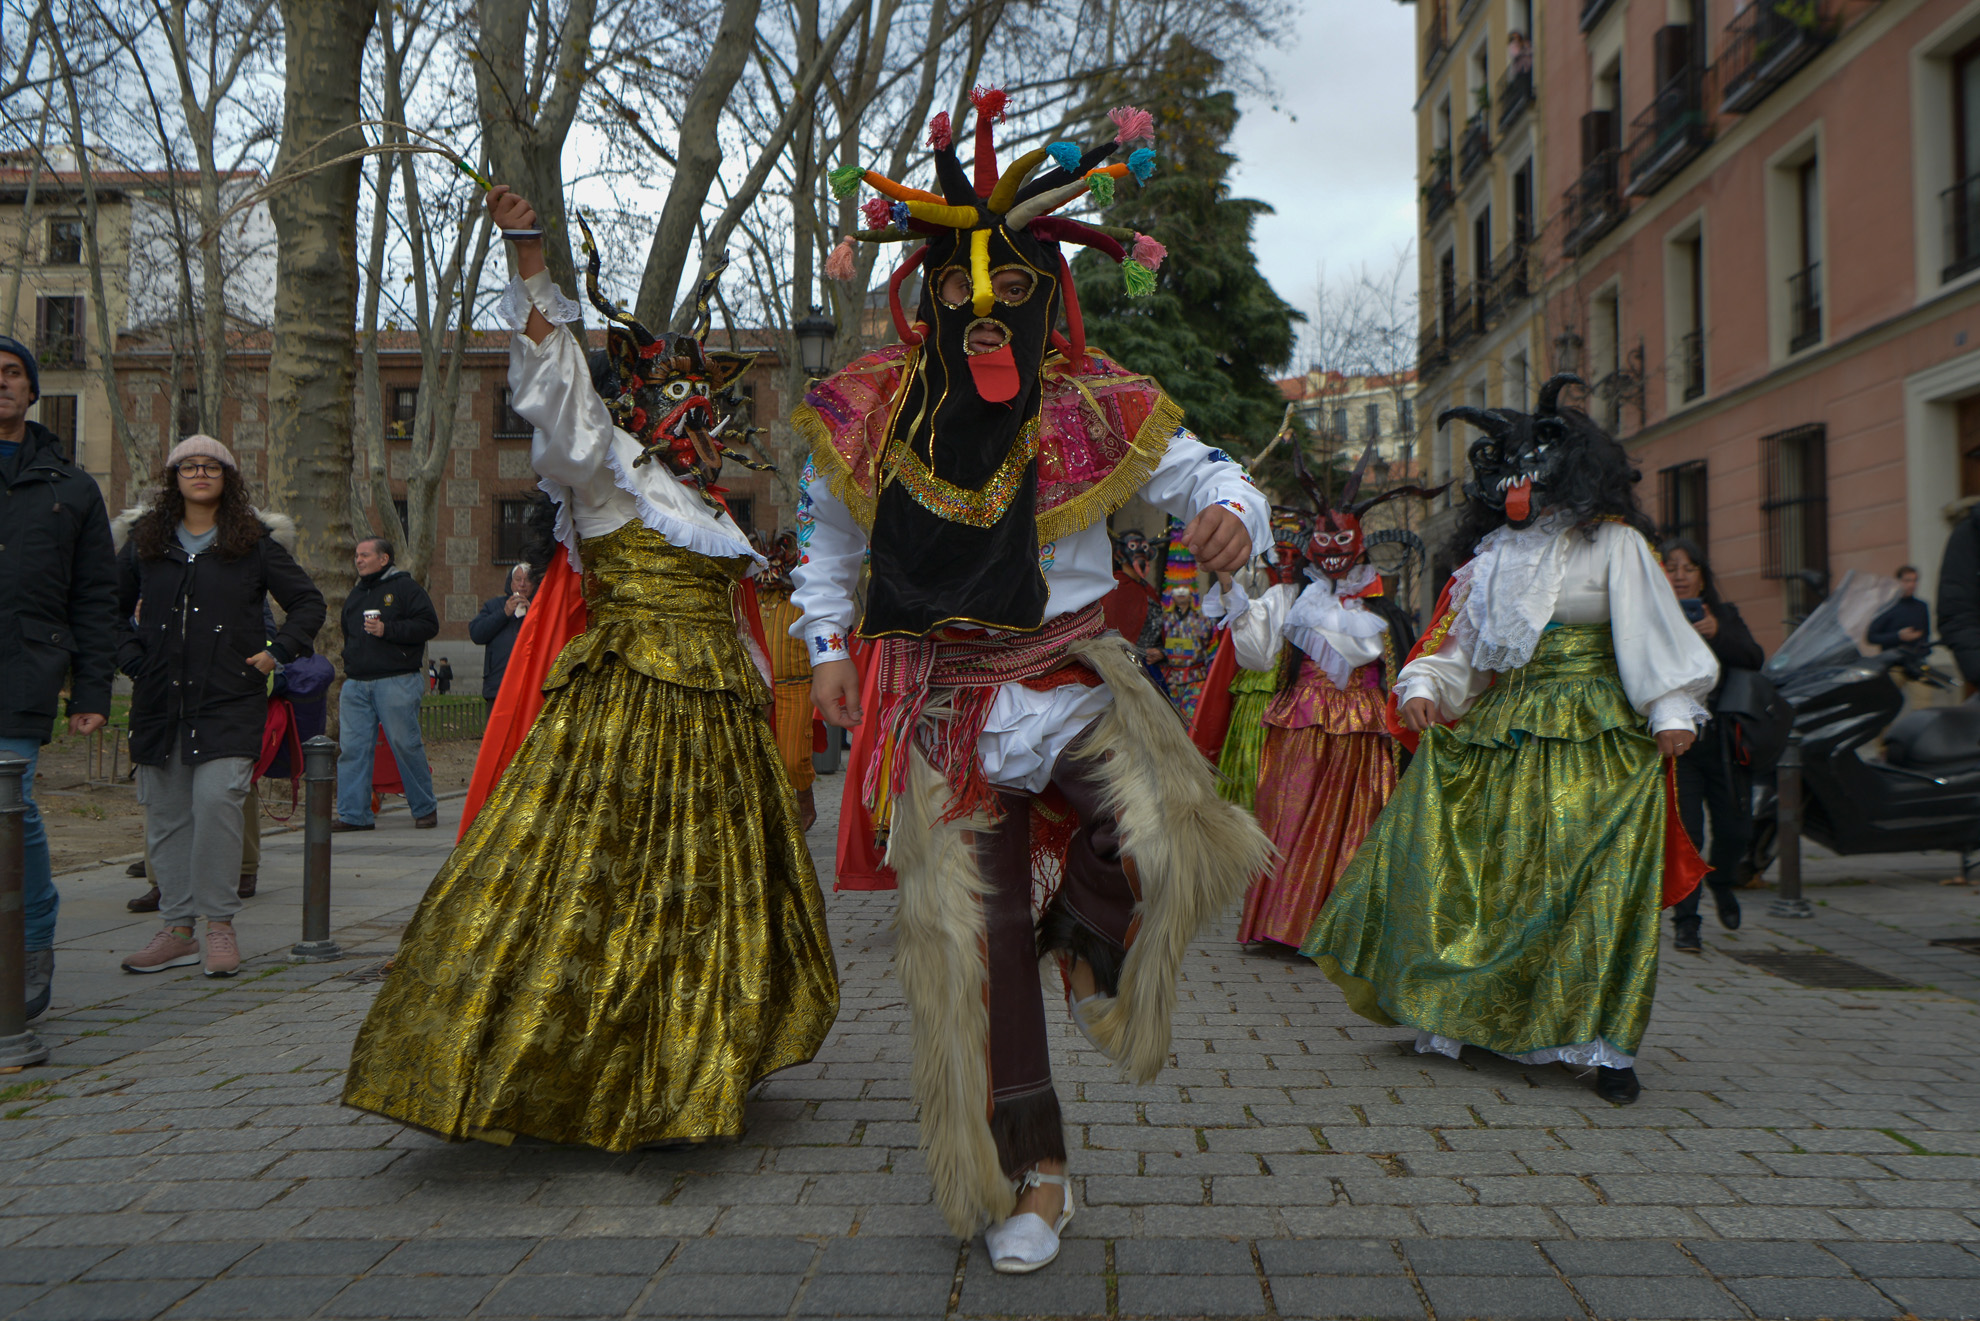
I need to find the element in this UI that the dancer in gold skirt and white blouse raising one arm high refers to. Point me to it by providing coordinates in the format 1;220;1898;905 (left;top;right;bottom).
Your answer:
345;188;840;1151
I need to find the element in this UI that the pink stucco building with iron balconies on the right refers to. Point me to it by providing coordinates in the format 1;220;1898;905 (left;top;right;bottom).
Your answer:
1420;0;1980;648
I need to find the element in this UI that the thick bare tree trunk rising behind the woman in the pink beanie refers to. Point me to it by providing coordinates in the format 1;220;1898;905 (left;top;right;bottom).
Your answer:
267;0;374;697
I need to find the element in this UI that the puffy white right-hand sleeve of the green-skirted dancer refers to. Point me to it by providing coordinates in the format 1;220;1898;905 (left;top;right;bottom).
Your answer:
1598;523;1719;733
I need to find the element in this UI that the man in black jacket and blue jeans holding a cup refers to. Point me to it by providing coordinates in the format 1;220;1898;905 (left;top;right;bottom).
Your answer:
331;537;440;830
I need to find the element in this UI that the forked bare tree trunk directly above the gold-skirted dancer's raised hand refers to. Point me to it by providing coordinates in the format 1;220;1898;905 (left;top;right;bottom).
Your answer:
473;0;594;289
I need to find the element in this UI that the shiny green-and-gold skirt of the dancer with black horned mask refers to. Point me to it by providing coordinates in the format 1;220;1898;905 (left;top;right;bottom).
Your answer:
1301;624;1665;1058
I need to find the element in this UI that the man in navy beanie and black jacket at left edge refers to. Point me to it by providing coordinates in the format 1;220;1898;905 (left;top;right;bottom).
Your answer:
0;337;117;1018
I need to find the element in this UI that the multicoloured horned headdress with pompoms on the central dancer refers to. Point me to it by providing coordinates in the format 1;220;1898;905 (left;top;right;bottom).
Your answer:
826;87;1168;362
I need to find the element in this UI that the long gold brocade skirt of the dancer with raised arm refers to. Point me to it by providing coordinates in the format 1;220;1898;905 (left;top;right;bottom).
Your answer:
345;525;840;1151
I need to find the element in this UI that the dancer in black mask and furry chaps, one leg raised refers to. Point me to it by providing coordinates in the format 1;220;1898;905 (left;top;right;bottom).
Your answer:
794;91;1271;1271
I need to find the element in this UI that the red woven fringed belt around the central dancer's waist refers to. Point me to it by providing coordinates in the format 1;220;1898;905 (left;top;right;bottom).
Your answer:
861;602;1107;822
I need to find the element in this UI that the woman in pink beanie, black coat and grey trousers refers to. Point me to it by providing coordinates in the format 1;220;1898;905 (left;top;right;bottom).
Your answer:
117;436;325;976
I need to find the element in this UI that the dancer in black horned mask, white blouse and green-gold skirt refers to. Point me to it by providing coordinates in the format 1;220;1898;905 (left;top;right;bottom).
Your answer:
1301;376;1719;1103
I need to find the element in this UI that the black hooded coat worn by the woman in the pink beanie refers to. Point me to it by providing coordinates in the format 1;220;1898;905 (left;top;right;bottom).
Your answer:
117;515;325;766
